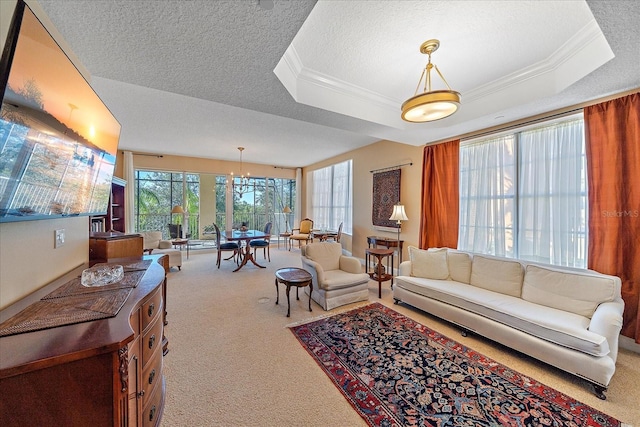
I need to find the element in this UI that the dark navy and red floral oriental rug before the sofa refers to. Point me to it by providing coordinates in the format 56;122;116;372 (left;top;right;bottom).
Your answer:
290;303;623;427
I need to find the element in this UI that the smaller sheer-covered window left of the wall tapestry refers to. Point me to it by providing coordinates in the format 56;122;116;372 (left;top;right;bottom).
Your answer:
310;160;353;234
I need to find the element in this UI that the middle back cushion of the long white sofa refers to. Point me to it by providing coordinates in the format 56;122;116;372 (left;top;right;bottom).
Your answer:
469;255;524;297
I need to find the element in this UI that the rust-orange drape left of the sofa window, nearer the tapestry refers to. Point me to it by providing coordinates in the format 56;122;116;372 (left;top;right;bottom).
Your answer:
418;139;460;249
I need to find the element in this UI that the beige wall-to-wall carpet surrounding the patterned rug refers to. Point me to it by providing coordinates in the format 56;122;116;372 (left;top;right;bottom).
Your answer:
162;247;640;427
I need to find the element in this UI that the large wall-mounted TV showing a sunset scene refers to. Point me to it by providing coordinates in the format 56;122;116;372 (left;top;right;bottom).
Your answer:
0;0;120;222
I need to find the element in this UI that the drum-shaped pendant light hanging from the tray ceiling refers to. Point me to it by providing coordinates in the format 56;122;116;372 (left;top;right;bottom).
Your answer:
402;39;460;123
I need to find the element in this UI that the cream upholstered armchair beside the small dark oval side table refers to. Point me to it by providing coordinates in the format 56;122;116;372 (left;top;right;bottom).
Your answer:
300;242;369;310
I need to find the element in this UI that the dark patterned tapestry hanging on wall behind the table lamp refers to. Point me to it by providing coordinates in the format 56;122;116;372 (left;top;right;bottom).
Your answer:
372;169;400;229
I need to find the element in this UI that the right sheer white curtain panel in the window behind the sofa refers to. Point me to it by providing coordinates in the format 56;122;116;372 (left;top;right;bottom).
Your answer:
518;120;587;267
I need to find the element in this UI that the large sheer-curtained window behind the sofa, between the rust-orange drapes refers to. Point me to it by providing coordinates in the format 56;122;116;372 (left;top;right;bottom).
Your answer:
458;116;587;268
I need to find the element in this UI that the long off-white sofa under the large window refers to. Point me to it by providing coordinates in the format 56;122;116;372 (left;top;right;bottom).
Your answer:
393;247;624;399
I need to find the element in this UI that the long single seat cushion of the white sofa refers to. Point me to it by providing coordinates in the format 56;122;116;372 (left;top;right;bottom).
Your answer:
394;274;610;357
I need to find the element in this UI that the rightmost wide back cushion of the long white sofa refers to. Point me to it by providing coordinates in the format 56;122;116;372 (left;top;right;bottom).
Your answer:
522;264;620;318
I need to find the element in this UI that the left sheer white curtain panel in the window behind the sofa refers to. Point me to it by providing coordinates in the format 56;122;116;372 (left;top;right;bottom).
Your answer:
458;135;516;257
